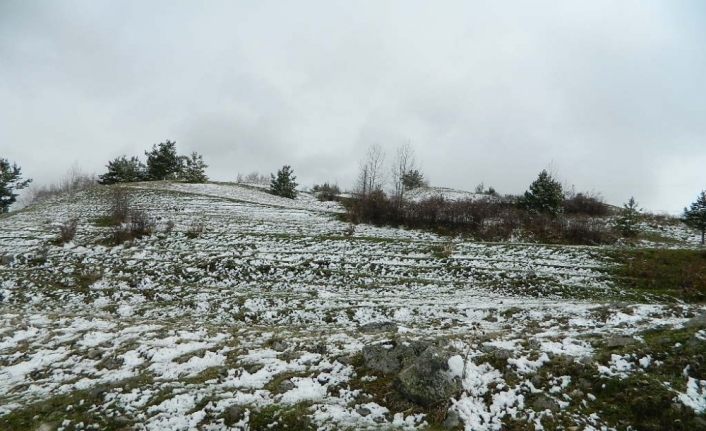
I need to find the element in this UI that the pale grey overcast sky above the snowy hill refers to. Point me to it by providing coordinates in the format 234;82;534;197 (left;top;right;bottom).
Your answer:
0;0;706;212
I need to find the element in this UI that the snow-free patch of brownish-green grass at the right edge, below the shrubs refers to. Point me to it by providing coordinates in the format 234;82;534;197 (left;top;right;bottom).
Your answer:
612;249;706;303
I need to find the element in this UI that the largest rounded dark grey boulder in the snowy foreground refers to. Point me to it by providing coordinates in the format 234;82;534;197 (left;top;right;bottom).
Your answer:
397;346;461;406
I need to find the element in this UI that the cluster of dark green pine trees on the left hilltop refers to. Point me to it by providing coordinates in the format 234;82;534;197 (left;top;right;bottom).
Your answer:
99;140;208;184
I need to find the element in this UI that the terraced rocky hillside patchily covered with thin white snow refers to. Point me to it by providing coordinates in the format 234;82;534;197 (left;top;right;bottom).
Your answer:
0;183;706;430
